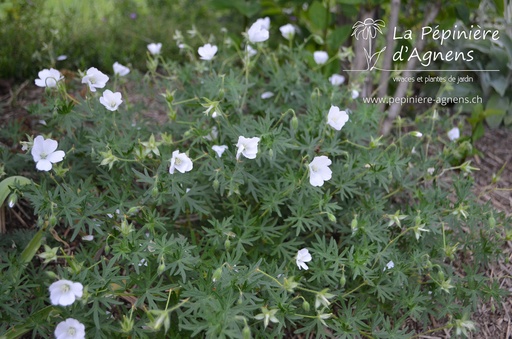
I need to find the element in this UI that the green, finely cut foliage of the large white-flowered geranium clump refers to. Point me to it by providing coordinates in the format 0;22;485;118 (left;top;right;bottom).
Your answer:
0;21;510;338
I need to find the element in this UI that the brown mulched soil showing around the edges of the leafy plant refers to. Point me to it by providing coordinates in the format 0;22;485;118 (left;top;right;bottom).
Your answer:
0;79;512;339
